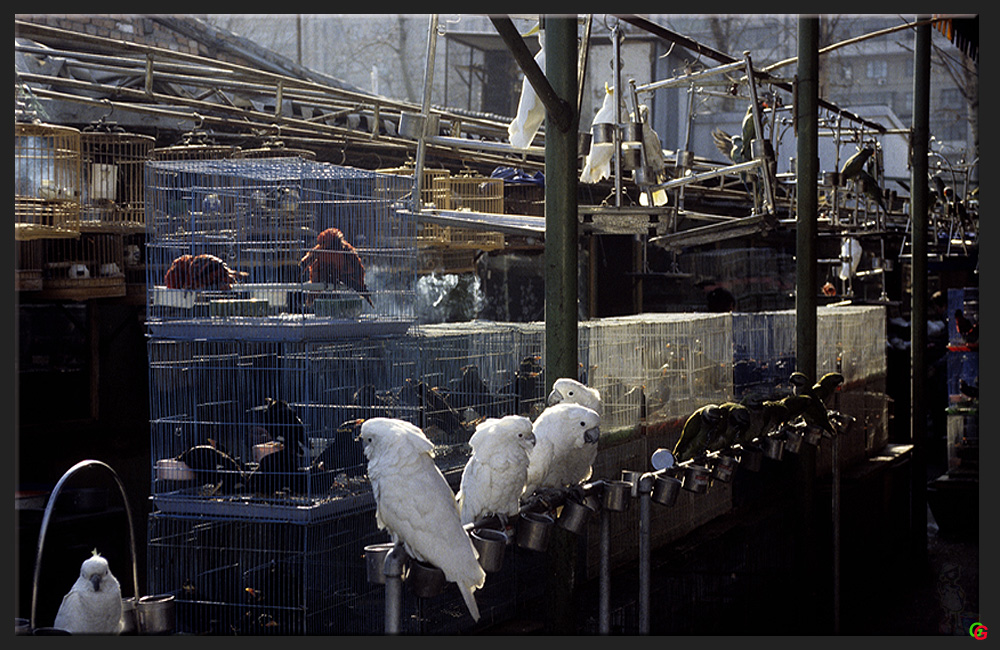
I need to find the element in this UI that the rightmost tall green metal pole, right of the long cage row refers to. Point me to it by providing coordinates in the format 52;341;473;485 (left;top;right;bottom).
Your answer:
910;16;931;558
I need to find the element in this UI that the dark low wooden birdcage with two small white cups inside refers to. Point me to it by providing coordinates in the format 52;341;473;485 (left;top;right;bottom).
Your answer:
41;232;126;300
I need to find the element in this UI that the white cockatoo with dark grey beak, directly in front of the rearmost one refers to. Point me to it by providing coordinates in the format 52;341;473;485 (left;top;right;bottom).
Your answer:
524;402;601;496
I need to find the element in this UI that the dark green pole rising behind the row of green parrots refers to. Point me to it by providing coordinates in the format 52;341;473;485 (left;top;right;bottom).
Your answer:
795;22;819;380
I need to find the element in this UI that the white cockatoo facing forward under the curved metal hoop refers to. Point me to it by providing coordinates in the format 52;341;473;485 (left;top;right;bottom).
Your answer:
53;549;124;635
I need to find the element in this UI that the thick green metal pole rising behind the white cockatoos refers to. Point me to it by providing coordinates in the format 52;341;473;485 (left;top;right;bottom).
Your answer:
544;15;579;634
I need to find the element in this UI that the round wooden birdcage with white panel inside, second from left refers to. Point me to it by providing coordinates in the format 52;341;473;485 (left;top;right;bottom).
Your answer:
75;123;156;233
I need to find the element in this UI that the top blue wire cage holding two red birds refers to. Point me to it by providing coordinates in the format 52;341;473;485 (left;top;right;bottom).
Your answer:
146;157;415;336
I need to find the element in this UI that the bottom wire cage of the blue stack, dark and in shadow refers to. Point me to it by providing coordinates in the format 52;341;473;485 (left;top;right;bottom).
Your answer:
147;508;390;636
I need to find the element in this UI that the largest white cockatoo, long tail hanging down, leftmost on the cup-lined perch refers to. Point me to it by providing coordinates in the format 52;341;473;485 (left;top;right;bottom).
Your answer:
359;417;486;621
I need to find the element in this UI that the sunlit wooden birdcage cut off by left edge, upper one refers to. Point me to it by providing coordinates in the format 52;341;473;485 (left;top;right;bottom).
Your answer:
14;122;81;241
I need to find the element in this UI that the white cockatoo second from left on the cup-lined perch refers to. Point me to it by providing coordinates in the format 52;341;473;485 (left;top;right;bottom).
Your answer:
455;415;535;524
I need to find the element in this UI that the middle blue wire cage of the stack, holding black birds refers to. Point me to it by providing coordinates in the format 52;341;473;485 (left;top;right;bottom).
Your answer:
148;337;418;508
